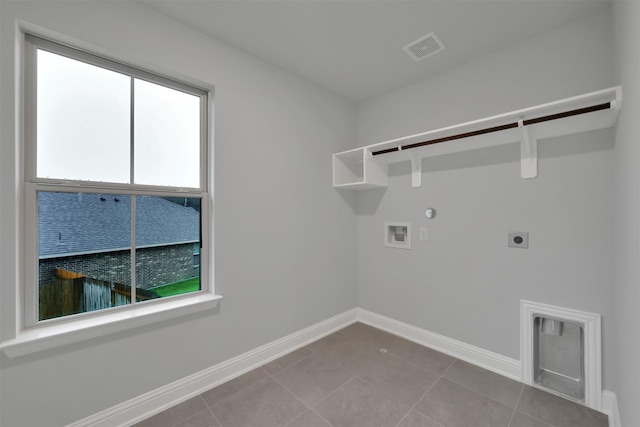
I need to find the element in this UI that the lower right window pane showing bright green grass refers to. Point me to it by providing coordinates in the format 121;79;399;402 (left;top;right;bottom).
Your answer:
136;196;200;301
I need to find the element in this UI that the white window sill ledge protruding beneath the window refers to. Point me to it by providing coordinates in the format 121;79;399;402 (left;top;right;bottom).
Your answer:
0;293;222;358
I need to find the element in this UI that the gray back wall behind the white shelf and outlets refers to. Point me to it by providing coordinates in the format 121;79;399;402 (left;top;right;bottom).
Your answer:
357;9;617;387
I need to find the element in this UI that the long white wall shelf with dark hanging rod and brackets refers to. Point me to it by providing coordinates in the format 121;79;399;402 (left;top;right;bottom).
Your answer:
333;86;622;190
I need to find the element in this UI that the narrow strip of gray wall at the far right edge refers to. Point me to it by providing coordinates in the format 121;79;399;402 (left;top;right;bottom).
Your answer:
613;1;640;426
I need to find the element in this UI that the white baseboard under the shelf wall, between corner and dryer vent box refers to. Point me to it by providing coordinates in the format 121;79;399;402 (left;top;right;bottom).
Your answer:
356;308;521;381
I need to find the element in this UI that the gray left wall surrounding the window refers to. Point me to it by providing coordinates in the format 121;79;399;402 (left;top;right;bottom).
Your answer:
0;1;356;427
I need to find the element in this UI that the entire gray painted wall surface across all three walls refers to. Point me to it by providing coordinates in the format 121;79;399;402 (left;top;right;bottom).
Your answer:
0;1;640;426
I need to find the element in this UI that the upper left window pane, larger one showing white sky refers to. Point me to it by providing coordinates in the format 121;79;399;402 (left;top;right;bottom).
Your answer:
37;50;131;183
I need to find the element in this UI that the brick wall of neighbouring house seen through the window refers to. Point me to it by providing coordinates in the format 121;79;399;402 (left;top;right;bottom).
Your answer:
40;243;200;289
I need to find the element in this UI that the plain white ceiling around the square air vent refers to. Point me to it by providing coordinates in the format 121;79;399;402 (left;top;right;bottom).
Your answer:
142;0;610;102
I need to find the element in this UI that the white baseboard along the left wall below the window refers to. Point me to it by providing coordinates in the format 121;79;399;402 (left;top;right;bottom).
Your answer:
68;309;357;427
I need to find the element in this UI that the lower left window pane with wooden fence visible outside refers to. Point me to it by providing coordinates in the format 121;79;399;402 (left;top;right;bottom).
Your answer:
38;191;131;320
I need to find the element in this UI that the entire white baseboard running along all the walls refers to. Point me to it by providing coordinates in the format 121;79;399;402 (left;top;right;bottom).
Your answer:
68;308;622;427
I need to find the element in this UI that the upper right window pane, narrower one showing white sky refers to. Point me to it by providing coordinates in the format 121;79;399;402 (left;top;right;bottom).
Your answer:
134;79;200;188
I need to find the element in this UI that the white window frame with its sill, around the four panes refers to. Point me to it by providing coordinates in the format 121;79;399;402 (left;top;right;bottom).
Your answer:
0;34;222;357
